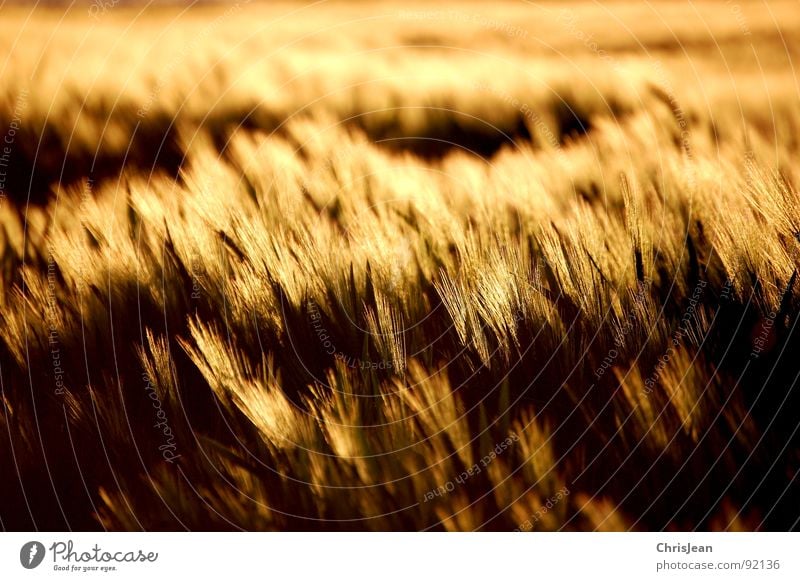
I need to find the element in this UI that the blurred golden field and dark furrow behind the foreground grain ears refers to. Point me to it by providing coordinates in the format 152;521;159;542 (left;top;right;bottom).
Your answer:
0;2;800;195
